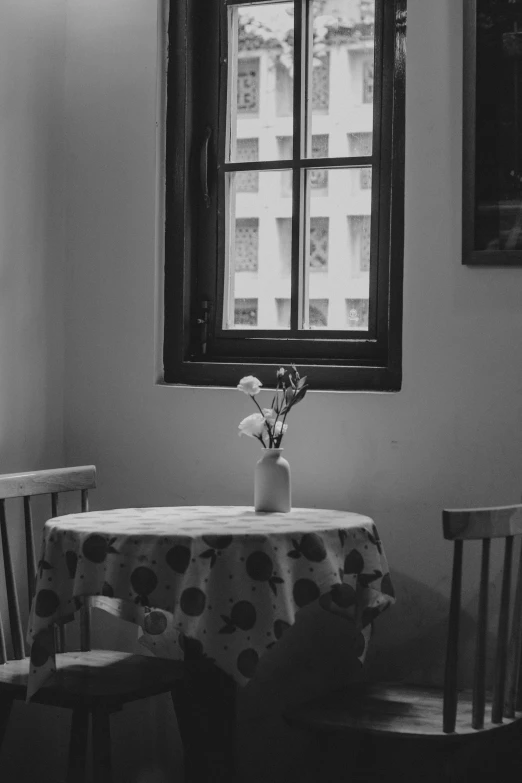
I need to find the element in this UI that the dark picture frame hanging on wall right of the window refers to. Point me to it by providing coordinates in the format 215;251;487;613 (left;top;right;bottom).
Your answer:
462;0;522;266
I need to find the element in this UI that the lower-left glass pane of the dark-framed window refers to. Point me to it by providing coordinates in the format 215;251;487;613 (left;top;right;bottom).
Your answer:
223;171;292;329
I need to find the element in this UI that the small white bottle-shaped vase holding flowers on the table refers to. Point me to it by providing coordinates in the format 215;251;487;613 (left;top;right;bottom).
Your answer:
254;449;292;513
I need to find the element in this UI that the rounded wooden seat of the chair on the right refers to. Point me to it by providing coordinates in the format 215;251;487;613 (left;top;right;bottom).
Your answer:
285;683;522;740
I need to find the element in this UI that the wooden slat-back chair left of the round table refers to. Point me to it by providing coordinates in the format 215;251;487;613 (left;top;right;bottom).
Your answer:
0;466;183;783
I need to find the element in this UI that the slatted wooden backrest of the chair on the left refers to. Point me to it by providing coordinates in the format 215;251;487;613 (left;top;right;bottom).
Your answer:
0;465;96;663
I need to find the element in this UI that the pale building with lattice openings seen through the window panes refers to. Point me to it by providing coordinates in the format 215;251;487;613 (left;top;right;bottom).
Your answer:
230;0;374;330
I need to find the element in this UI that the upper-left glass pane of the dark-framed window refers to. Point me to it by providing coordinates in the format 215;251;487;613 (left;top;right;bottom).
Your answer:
228;3;294;162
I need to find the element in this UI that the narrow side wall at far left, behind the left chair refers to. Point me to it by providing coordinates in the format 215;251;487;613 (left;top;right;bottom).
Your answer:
0;0;67;783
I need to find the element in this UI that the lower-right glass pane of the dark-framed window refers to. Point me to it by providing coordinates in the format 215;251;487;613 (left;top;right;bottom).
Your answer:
303;168;371;330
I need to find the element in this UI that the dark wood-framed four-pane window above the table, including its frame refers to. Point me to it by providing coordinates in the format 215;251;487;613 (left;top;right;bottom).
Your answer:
160;0;406;391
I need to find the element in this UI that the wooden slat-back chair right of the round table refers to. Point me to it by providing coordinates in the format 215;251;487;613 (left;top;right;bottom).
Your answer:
285;505;522;780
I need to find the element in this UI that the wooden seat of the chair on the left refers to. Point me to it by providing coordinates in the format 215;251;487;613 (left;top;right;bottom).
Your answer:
0;650;183;709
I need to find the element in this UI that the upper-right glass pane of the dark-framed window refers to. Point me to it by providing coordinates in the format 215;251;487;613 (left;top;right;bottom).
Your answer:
307;0;375;158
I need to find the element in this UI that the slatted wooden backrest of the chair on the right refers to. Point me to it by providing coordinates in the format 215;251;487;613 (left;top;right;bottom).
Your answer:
442;505;522;733
